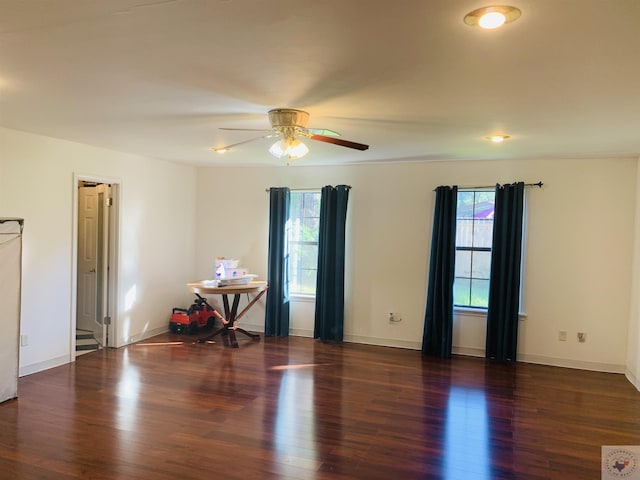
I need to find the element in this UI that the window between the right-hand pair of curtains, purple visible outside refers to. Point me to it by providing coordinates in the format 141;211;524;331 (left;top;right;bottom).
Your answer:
453;190;495;309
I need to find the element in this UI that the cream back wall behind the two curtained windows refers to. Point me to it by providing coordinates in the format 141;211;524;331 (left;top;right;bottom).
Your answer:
196;159;637;372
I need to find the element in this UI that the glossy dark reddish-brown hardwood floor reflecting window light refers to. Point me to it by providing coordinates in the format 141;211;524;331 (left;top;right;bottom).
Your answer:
0;334;640;480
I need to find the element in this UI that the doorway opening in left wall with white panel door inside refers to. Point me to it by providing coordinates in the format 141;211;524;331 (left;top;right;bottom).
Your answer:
72;177;118;357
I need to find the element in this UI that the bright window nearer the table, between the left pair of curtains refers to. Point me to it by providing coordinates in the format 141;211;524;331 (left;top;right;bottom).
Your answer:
289;190;320;295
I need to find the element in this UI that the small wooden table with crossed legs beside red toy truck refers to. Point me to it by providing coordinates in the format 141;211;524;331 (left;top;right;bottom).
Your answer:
187;280;268;348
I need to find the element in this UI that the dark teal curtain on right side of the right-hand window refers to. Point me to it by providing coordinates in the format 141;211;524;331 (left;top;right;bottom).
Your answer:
485;182;524;362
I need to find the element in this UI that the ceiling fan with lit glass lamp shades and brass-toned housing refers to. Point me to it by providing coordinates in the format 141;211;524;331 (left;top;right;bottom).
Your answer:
212;108;369;160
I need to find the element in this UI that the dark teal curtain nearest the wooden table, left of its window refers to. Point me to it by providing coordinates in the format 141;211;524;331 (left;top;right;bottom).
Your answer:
264;187;290;337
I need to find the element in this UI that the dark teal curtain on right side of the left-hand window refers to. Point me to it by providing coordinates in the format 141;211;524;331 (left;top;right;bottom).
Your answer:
313;185;351;342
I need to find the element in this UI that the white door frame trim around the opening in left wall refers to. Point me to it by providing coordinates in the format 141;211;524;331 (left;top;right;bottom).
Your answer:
69;173;122;362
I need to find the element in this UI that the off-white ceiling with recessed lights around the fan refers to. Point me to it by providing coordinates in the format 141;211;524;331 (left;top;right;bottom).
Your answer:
0;0;640;165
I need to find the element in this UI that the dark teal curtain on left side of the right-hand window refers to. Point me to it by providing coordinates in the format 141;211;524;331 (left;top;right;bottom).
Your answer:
422;185;458;358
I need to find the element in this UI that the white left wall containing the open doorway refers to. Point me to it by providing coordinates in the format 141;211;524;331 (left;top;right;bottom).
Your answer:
0;128;196;375
